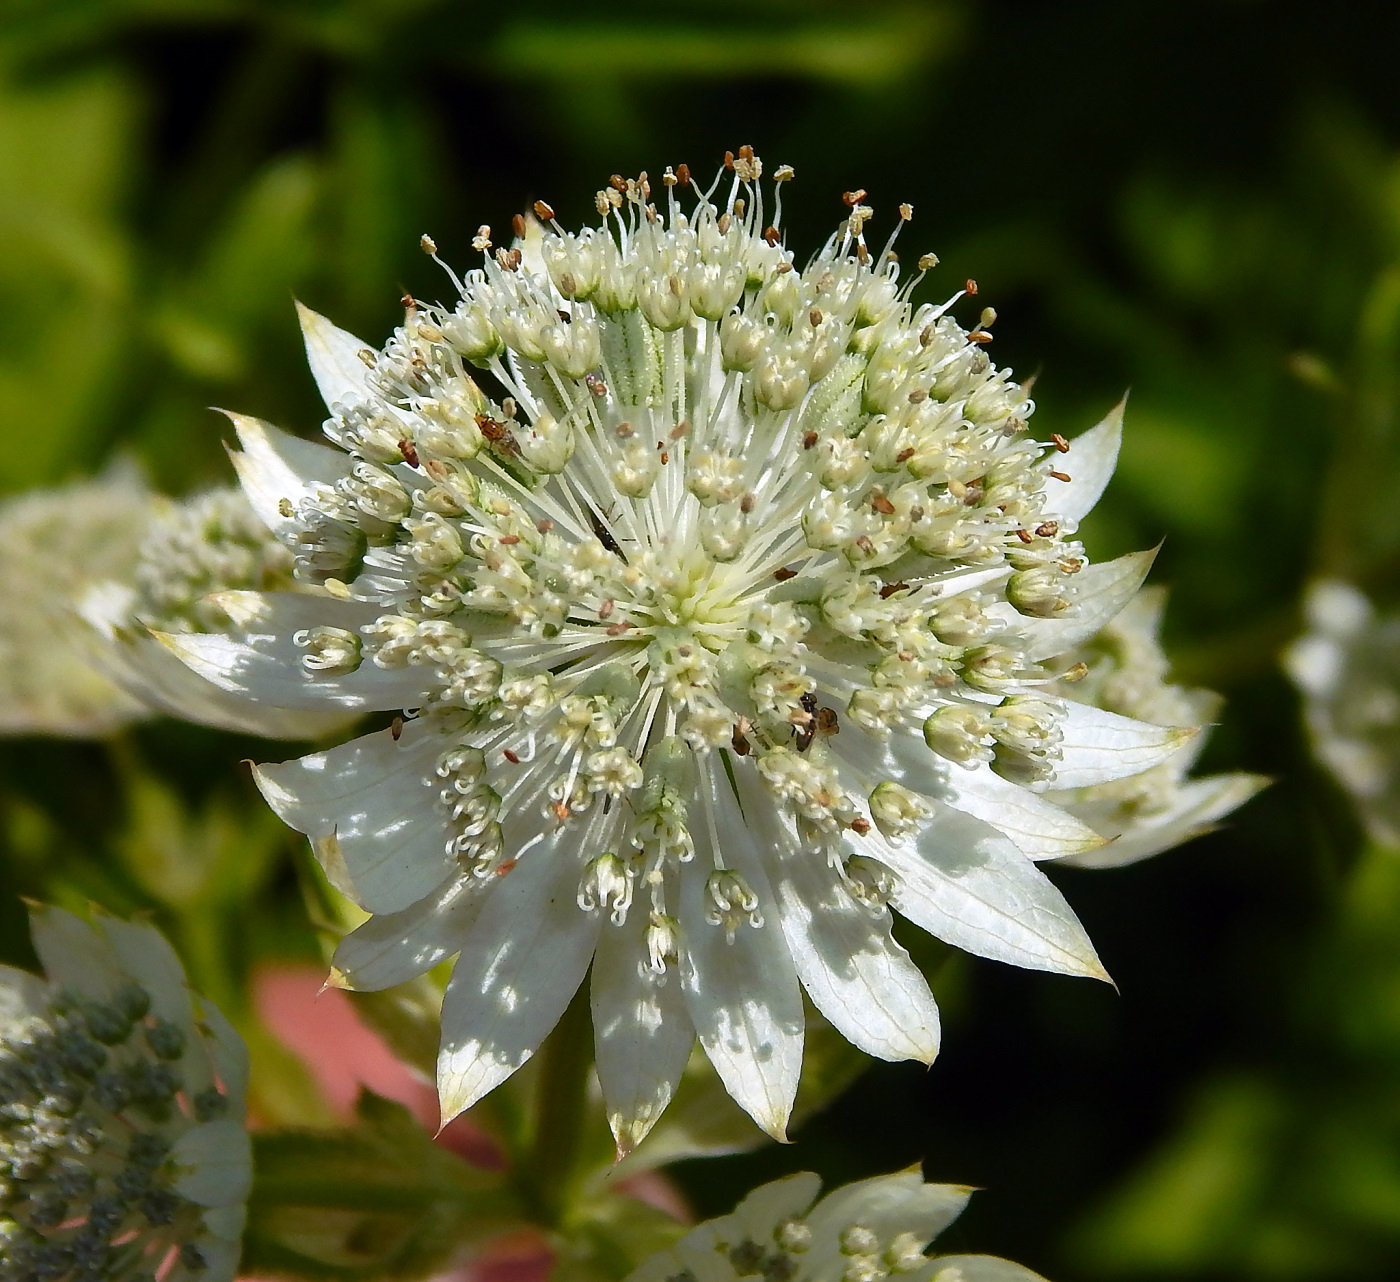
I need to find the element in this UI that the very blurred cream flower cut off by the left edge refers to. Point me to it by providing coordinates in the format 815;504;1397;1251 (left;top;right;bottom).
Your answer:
0;467;155;736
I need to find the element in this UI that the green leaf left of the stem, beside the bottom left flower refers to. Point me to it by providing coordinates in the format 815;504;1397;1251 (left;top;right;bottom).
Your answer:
244;1090;522;1282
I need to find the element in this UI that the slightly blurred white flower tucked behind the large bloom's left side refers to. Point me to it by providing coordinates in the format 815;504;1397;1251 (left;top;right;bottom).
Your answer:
81;488;355;739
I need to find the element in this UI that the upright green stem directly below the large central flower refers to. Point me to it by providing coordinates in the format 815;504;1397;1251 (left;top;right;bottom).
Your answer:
519;984;594;1229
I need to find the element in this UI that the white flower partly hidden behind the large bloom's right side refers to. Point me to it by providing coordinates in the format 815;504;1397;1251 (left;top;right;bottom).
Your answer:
1046;588;1268;868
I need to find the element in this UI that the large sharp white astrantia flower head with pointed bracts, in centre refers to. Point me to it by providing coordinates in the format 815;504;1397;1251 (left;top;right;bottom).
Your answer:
172;151;1193;1150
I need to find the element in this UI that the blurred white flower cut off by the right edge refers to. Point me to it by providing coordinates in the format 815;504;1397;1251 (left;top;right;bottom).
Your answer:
1284;579;1400;847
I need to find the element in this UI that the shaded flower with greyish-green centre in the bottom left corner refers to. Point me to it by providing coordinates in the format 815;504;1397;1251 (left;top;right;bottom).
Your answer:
0;907;252;1282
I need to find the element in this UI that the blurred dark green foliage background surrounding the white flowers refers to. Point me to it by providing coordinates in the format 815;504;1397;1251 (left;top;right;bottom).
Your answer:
0;0;1400;1282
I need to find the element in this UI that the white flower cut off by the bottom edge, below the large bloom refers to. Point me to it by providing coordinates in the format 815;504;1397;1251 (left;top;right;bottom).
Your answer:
627;1171;1043;1282
